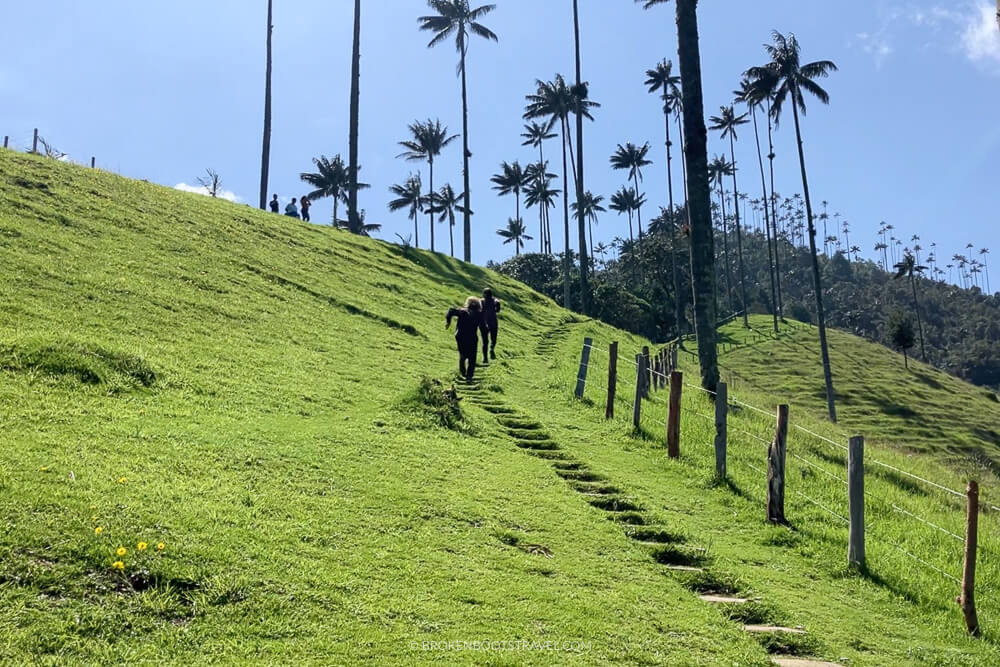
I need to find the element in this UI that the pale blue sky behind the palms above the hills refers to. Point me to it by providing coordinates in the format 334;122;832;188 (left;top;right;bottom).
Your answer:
0;0;1000;282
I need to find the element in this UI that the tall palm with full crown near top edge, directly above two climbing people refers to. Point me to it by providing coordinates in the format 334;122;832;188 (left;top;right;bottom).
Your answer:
416;0;499;262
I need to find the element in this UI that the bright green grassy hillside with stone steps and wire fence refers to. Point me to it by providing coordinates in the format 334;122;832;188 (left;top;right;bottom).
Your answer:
0;151;1000;665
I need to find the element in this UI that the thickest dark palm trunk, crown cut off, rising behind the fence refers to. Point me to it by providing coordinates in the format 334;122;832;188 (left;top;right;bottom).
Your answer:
676;0;719;392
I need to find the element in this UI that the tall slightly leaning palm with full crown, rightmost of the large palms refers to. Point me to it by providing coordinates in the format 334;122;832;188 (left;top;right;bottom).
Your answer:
748;31;837;422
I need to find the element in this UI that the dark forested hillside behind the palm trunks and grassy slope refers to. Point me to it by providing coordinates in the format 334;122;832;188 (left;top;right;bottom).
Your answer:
494;217;1000;388
